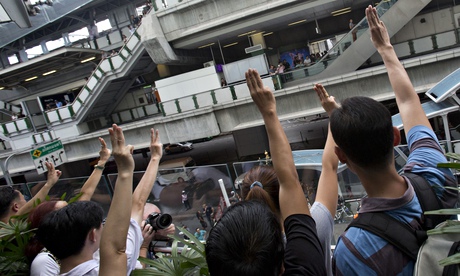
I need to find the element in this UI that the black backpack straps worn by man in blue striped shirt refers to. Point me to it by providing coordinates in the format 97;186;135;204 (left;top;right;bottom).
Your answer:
345;173;460;268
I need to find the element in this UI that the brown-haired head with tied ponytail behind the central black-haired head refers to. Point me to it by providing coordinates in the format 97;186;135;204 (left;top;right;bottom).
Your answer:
241;166;280;214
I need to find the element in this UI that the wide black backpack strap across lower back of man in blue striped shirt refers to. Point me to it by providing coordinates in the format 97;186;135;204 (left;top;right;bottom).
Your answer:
345;212;427;260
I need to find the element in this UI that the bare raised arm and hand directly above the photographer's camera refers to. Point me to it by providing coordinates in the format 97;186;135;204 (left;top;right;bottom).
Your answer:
131;128;163;225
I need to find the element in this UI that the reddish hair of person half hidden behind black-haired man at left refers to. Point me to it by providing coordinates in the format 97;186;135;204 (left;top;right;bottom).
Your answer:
25;201;57;262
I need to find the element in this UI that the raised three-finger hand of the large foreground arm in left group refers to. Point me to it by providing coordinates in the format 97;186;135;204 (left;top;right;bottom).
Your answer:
109;124;134;174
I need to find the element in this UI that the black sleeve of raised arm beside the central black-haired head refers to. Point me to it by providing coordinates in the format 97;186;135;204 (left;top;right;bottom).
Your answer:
283;214;327;275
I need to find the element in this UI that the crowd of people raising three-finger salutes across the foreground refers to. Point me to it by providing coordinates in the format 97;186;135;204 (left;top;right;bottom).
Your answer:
0;6;458;275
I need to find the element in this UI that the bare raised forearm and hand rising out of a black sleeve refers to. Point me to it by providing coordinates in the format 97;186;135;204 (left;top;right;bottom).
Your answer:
246;69;310;220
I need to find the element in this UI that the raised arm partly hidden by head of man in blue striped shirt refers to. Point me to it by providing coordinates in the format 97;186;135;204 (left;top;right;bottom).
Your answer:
313;84;339;217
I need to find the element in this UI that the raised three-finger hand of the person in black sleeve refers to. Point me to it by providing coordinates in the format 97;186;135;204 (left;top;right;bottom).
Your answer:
245;69;276;116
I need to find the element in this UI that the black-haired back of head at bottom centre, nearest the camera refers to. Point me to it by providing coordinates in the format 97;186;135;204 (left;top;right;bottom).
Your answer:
206;201;284;276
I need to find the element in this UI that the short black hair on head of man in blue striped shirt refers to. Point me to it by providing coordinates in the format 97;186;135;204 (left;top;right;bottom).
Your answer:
330;97;394;168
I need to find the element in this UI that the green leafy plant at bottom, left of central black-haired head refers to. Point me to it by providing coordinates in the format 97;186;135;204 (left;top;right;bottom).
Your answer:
131;227;209;276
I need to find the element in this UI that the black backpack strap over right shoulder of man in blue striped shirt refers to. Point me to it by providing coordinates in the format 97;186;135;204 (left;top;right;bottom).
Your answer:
402;172;449;230
